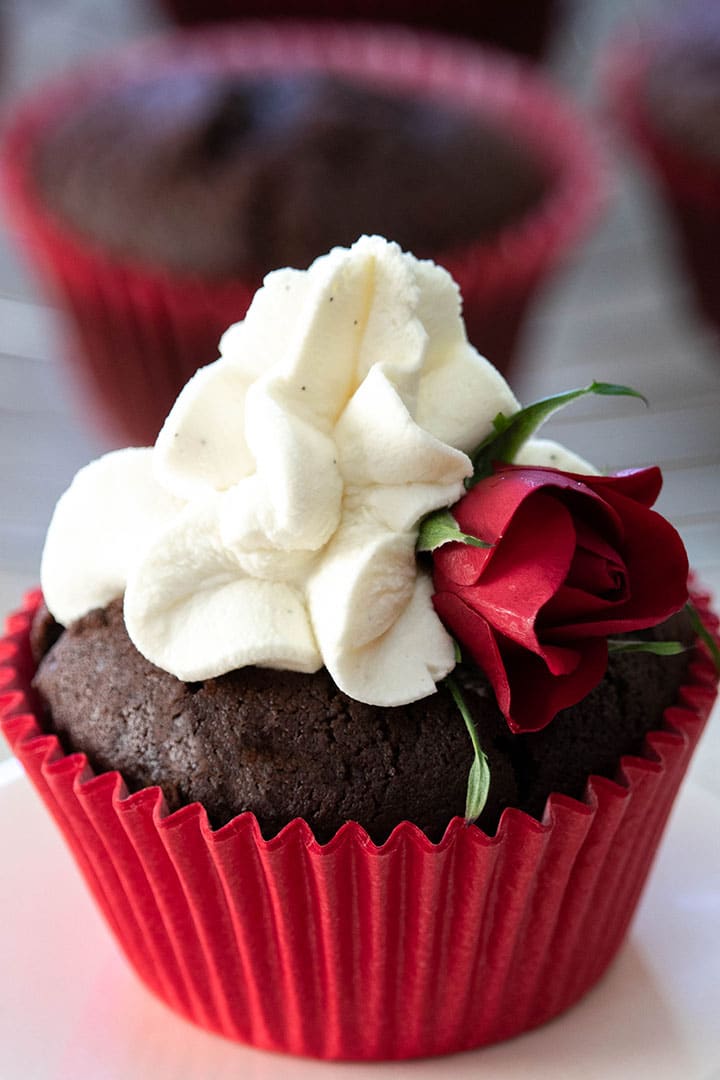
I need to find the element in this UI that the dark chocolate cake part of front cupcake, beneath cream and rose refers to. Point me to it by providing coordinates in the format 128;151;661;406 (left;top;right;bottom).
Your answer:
33;600;692;842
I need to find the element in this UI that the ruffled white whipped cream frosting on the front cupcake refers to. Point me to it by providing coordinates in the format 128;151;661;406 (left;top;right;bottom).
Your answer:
41;237;594;705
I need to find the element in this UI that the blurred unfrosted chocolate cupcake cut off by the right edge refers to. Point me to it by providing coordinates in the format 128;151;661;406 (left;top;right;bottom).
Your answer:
607;3;720;341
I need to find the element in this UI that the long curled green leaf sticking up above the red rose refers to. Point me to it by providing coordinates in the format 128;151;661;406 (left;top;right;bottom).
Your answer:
465;381;648;489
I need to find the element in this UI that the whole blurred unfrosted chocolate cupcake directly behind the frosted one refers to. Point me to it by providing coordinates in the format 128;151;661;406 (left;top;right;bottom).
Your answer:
4;23;600;445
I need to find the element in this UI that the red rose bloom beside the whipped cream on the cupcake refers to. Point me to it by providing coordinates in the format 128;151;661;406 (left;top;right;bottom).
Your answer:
433;465;688;731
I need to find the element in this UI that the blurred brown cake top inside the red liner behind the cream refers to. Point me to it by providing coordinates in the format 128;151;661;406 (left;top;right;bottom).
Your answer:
36;72;548;276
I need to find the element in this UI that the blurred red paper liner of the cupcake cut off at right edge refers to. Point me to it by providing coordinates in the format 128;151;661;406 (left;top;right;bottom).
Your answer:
604;43;720;332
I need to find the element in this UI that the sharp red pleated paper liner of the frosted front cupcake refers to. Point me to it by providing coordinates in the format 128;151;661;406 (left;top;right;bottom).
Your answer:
0;594;717;1059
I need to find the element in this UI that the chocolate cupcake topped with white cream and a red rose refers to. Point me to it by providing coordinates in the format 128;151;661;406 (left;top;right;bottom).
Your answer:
0;237;717;1059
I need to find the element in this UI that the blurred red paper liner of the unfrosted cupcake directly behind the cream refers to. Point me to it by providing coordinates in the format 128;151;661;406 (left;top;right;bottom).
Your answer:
2;22;604;444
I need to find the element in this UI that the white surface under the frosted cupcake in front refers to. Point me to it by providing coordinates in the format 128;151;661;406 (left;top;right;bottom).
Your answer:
0;761;720;1080
